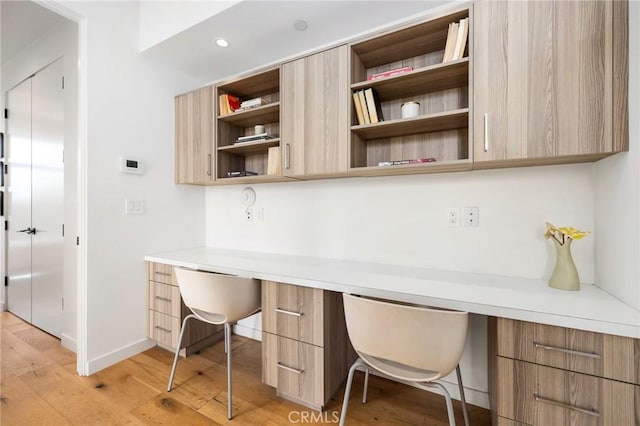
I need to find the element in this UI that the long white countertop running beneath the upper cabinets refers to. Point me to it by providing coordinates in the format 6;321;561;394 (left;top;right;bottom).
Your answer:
145;247;640;338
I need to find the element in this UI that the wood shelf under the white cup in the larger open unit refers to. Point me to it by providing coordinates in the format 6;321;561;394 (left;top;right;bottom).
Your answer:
351;108;469;139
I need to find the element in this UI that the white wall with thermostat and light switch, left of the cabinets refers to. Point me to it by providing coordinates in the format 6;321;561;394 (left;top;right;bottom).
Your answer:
58;2;204;373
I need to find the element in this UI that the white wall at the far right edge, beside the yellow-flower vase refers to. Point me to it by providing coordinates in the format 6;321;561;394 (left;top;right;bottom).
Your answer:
595;1;640;310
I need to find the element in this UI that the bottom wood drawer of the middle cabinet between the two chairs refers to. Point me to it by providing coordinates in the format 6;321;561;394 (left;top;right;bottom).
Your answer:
262;332;324;409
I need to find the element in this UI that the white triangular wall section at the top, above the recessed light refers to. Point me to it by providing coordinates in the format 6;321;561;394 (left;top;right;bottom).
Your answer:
139;0;240;51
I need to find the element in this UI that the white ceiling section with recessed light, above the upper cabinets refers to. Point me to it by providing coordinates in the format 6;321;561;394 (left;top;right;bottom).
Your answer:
144;0;450;84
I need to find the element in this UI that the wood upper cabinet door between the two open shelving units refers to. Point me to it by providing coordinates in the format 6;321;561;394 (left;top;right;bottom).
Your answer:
280;46;350;176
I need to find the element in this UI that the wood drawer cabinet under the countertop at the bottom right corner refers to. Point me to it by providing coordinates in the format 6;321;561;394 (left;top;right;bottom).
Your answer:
491;318;640;426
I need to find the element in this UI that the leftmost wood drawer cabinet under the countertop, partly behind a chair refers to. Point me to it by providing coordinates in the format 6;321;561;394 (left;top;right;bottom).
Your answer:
147;262;224;355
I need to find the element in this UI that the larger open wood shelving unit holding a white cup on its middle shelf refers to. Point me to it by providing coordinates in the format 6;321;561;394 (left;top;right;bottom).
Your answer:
349;8;472;175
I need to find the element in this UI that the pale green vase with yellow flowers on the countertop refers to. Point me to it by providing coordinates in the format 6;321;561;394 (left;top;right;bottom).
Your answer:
544;222;591;291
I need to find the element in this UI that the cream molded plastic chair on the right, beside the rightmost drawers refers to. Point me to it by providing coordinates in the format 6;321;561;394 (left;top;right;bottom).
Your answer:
340;294;469;426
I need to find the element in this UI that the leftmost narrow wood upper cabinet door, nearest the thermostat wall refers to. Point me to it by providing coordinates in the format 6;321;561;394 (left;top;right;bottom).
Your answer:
175;86;215;184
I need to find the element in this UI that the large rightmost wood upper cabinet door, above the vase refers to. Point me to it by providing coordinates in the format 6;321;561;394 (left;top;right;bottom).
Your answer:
473;1;627;167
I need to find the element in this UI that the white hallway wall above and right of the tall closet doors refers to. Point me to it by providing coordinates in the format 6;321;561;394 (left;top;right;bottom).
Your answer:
1;20;78;351
